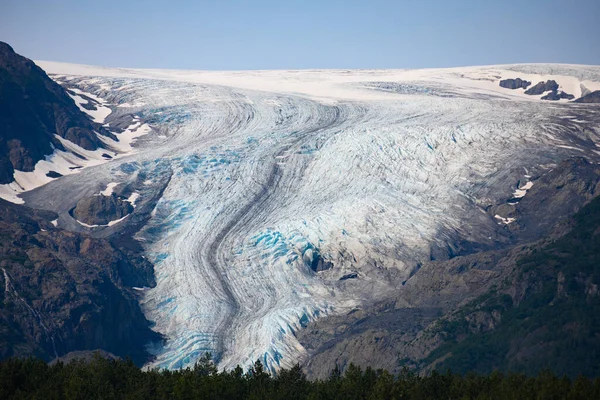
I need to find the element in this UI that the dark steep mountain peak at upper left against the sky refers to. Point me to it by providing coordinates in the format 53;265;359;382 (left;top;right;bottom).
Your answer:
0;42;113;184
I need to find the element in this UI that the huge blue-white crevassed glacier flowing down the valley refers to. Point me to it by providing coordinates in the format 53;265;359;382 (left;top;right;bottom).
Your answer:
8;62;600;371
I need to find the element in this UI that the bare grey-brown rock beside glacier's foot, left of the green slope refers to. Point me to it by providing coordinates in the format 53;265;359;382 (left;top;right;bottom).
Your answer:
296;251;508;378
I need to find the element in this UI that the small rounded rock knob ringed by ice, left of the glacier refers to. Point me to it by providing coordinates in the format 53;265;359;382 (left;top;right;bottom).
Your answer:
73;193;133;225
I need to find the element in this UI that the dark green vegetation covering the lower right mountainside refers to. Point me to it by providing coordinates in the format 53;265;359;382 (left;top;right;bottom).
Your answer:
425;198;600;378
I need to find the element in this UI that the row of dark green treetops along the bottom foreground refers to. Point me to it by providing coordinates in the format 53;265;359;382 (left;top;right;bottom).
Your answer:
0;354;600;400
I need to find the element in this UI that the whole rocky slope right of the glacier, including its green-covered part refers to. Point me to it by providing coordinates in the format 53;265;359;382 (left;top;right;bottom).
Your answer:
299;158;600;377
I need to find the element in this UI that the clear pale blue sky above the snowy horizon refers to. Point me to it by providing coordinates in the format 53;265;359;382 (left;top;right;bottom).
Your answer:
0;0;600;70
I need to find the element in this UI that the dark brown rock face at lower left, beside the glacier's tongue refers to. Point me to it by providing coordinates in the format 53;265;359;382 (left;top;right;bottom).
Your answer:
0;199;160;364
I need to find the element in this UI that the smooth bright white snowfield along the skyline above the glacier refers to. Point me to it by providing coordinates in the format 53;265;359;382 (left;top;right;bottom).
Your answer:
37;61;600;106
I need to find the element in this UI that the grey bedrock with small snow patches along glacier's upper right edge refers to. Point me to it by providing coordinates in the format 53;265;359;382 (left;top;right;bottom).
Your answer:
418;157;600;261
